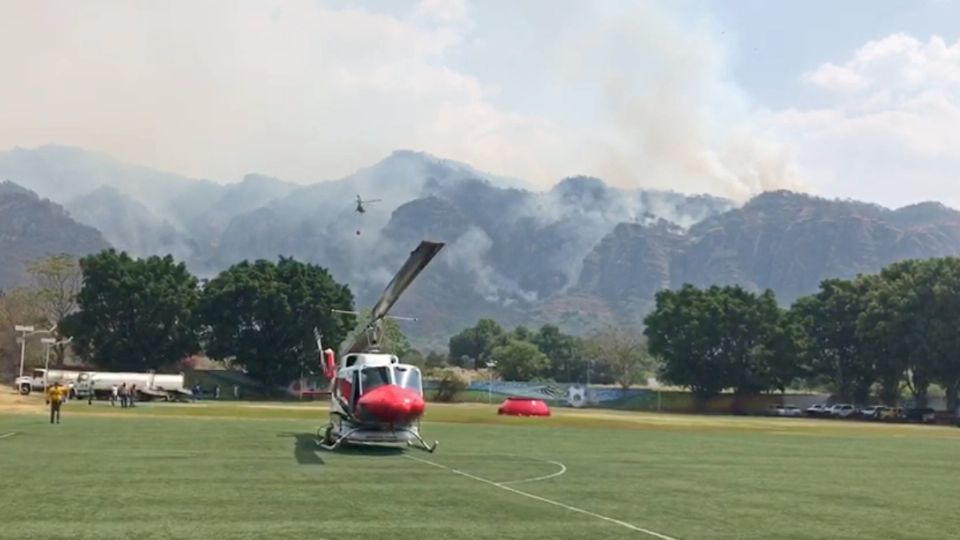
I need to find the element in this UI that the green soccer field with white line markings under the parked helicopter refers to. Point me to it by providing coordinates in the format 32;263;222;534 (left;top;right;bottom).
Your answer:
0;401;960;540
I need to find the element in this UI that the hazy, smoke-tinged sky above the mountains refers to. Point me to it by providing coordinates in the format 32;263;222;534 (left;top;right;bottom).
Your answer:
0;0;960;206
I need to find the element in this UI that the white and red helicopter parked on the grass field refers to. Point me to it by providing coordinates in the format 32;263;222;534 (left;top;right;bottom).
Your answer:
314;241;444;452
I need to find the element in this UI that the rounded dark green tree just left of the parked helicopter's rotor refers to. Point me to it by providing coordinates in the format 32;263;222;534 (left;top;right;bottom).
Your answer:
198;257;354;389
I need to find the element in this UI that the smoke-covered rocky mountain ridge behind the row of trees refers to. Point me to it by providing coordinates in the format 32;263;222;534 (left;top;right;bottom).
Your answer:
0;147;960;346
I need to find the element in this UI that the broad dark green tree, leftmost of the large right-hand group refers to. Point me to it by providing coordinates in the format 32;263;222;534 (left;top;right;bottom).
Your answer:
644;285;791;405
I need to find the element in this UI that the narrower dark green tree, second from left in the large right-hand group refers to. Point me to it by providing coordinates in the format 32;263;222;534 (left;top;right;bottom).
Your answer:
792;279;876;403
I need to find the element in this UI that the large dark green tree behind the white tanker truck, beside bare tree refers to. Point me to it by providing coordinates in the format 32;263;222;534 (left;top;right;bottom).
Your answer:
62;249;200;370
